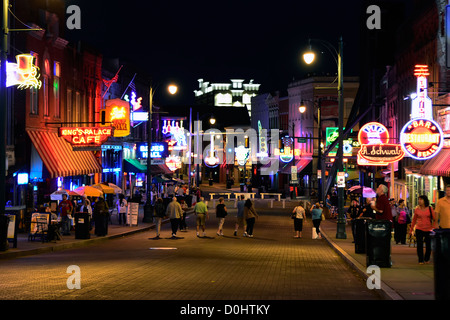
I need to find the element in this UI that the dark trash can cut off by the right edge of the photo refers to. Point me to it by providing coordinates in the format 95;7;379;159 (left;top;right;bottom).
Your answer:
431;229;450;300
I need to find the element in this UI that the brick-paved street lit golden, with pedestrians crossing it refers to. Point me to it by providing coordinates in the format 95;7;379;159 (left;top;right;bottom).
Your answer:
0;208;380;300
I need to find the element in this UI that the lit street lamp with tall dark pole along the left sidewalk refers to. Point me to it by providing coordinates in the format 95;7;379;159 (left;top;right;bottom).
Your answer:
143;84;178;222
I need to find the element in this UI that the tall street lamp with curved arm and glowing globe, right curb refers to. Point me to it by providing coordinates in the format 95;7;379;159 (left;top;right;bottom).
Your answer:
303;37;347;239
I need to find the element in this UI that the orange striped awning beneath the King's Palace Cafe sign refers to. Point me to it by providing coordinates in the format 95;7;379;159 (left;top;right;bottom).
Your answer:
27;130;102;178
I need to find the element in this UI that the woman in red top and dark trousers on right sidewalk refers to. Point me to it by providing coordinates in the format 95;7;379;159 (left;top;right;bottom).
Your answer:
410;195;436;264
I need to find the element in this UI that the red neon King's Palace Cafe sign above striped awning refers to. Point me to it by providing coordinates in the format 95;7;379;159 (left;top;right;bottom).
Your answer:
58;127;113;146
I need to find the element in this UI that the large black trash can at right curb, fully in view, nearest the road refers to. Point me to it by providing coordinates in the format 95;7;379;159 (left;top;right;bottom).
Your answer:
366;220;392;268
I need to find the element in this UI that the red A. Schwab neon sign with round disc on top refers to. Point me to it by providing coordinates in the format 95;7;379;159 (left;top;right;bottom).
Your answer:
357;122;405;166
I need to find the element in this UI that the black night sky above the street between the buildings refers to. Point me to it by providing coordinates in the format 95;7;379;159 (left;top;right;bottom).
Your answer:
66;0;366;104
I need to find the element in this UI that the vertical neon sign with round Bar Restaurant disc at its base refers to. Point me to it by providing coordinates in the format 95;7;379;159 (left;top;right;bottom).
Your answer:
400;65;444;160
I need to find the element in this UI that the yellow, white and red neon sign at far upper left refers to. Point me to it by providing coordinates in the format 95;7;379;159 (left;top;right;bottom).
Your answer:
6;53;42;89
